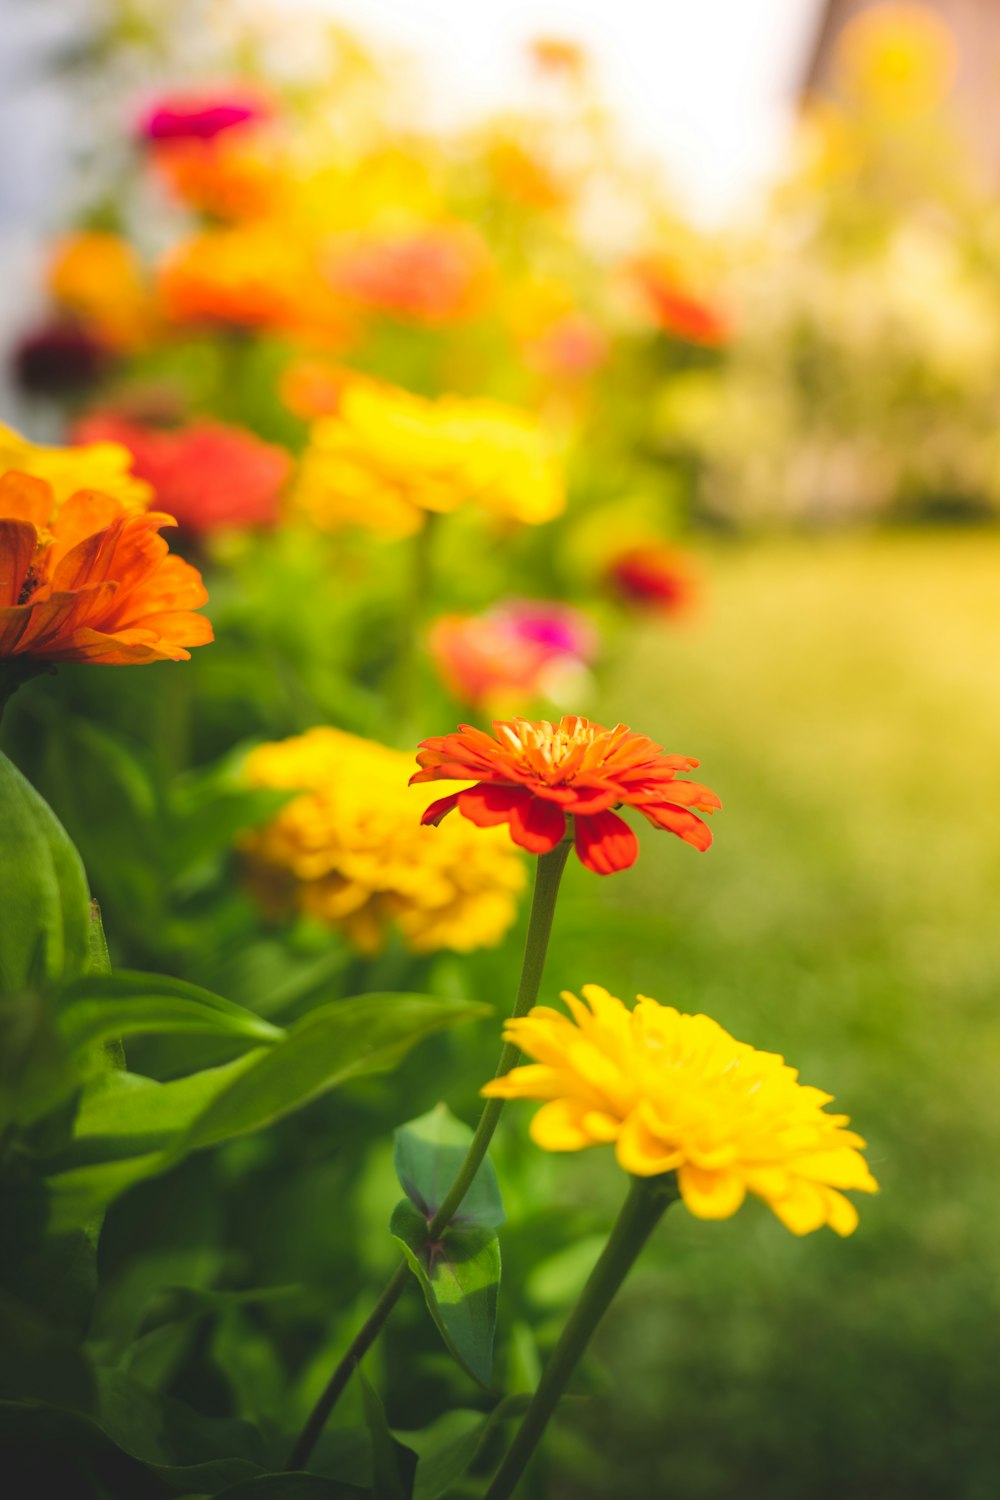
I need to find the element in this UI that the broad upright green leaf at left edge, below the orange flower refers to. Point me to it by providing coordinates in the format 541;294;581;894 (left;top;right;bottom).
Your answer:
0;755;90;995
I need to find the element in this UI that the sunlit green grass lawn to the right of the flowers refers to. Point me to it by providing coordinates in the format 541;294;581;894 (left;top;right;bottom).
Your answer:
514;534;1000;1500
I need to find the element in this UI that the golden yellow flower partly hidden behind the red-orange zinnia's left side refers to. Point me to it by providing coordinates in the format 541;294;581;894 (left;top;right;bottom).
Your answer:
244;728;525;953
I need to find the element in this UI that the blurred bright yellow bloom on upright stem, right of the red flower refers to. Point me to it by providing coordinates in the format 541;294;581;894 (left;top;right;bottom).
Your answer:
298;381;565;537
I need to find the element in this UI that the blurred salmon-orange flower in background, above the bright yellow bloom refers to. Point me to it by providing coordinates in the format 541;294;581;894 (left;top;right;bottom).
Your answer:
328;224;490;327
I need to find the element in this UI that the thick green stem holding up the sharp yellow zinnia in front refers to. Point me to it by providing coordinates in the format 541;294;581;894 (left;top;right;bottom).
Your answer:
483;1178;676;1500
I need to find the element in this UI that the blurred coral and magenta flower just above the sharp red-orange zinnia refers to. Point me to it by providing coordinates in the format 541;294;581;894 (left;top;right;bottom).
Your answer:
430;599;597;708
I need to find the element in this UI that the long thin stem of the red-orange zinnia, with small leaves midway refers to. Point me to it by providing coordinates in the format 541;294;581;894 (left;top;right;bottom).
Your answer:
285;839;571;1470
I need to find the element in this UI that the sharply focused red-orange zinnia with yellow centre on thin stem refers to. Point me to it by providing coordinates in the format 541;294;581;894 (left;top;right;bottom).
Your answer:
411;714;723;875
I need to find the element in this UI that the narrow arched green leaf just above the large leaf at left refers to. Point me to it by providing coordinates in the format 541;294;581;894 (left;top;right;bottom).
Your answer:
58;971;285;1055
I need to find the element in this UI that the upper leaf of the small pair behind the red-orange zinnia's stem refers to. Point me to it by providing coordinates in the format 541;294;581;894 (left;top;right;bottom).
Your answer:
393;1104;504;1229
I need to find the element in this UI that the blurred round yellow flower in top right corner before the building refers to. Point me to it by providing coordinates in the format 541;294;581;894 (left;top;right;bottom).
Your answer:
837;3;957;114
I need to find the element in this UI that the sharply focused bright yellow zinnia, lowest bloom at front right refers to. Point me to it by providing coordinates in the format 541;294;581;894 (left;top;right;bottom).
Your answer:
483;984;877;1235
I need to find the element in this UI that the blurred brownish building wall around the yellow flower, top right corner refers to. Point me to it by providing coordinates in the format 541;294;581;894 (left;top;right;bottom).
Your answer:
802;0;1000;172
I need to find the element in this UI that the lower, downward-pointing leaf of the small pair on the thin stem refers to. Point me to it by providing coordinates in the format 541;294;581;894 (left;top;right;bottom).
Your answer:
390;1199;501;1389
